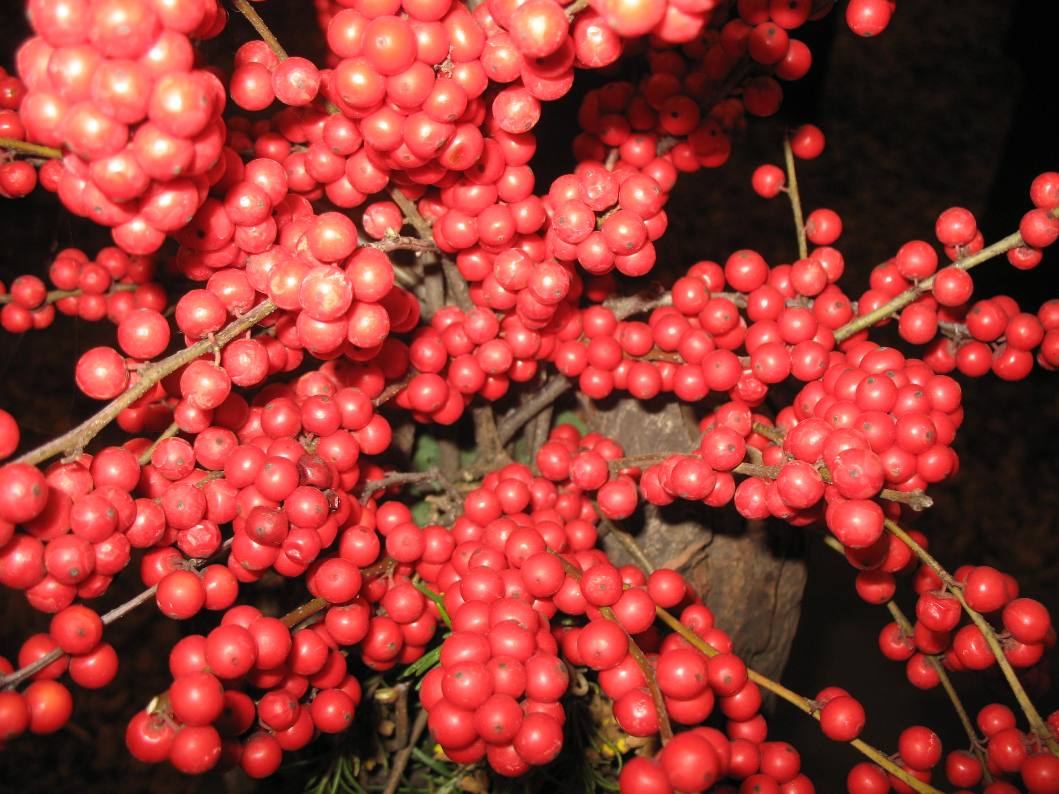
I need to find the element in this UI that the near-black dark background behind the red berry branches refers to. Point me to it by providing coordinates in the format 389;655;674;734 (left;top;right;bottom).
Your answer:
0;0;1059;792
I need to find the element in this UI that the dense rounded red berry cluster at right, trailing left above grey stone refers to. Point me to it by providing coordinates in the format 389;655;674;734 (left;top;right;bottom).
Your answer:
537;332;963;531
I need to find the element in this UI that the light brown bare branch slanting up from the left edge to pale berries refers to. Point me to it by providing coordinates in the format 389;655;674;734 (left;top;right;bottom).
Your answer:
17;300;276;464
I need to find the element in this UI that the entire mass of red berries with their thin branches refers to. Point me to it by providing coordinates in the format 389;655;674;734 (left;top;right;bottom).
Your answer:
0;0;1059;794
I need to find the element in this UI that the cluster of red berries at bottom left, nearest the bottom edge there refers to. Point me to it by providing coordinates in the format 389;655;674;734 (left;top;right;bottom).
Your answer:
125;601;361;778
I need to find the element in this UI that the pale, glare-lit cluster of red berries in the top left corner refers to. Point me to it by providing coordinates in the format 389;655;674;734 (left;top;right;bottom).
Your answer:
17;0;228;254
